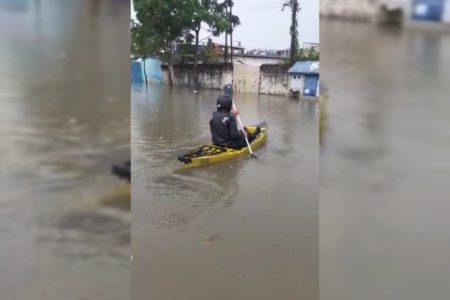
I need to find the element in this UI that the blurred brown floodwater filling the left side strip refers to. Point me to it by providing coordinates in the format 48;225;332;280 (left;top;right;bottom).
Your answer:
0;0;131;300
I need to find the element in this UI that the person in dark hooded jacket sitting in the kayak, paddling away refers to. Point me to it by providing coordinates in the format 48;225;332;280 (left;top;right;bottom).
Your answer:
209;89;261;149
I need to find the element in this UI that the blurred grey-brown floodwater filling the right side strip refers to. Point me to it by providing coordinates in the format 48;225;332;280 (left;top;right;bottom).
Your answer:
320;20;450;300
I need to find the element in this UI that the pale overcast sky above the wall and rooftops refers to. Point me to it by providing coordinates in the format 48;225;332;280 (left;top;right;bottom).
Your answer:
131;0;319;50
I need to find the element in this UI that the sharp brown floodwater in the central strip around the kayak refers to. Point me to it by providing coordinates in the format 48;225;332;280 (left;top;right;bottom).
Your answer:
131;85;319;300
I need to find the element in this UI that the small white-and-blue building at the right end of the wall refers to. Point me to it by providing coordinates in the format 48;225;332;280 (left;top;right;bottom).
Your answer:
288;61;320;97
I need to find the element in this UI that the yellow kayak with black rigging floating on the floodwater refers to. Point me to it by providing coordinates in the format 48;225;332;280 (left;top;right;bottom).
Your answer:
178;123;268;169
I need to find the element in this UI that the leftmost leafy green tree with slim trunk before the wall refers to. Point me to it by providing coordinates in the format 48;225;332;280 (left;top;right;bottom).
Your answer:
133;0;196;86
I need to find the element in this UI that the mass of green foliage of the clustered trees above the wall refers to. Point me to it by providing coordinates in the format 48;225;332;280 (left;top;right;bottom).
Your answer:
131;0;240;86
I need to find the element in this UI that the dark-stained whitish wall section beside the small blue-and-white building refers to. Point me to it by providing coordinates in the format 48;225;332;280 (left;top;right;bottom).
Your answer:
259;65;289;96
